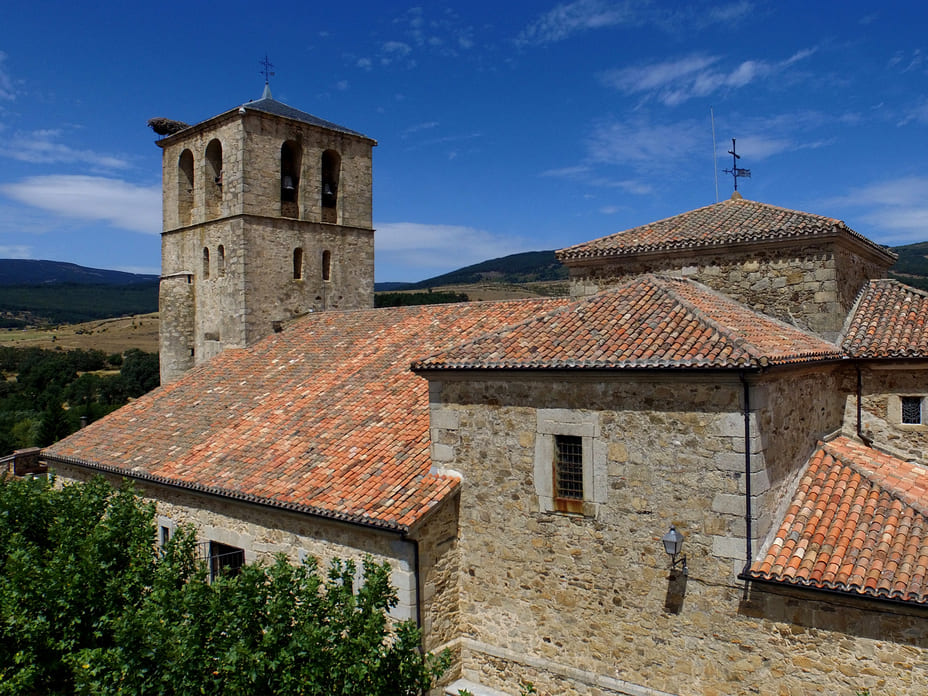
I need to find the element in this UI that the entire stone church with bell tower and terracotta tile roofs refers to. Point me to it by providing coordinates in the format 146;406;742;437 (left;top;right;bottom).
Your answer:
25;91;928;696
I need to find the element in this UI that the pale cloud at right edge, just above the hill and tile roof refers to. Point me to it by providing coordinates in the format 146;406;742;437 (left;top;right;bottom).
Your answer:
823;176;928;244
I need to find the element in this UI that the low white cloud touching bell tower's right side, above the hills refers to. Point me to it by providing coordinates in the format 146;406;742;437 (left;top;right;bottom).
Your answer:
374;222;535;281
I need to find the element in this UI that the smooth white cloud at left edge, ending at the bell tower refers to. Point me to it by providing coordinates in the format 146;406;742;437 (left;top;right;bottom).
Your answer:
0;175;161;234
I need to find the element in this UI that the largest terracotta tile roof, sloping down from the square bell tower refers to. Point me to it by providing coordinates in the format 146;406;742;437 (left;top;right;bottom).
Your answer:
44;299;566;529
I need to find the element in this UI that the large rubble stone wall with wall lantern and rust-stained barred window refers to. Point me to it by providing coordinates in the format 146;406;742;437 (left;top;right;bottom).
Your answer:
431;372;928;696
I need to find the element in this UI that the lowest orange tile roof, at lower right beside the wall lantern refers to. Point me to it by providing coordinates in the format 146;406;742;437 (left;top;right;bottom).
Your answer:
748;437;928;604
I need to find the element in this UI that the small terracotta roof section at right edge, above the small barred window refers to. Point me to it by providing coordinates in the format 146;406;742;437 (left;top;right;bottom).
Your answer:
842;280;928;358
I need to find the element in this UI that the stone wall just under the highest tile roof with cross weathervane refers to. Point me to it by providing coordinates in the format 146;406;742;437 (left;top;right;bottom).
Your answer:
570;241;886;340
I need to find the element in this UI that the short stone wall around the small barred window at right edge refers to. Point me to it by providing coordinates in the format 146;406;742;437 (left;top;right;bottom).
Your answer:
845;363;928;462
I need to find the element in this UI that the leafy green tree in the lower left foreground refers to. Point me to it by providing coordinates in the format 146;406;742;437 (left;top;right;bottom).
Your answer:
0;480;448;696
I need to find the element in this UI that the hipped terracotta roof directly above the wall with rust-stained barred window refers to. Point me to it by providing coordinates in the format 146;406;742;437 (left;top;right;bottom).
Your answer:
413;275;842;370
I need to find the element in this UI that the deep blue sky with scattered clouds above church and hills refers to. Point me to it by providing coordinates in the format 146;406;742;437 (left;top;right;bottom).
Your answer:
0;0;928;281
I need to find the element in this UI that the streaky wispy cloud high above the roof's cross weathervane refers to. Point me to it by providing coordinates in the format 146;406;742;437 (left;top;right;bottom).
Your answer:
600;49;815;106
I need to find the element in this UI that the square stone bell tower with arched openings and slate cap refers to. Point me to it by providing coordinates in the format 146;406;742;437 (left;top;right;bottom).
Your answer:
157;85;377;384
